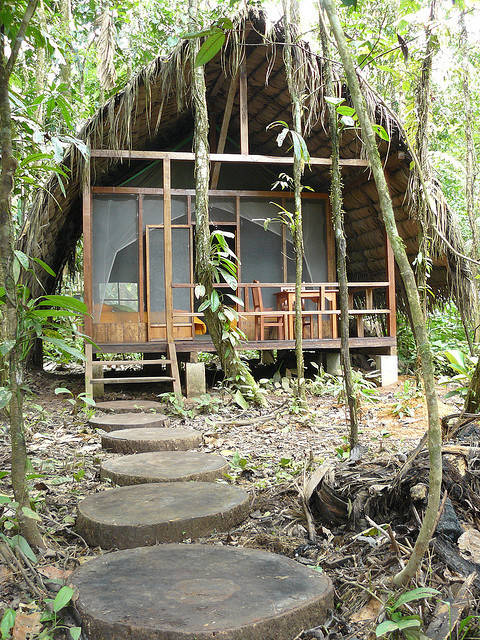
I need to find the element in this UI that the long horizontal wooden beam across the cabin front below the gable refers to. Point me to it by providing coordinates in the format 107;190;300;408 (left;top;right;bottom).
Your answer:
91;149;369;166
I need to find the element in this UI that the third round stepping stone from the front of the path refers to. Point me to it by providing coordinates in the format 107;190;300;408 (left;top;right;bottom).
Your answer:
100;451;228;486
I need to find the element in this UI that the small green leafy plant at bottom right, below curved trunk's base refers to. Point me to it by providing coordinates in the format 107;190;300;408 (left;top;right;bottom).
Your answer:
375;587;440;640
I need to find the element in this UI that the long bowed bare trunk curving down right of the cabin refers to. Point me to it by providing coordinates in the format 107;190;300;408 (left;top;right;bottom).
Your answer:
322;0;442;585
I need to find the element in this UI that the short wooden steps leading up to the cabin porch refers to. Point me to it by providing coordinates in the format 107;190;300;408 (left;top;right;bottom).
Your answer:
85;342;182;398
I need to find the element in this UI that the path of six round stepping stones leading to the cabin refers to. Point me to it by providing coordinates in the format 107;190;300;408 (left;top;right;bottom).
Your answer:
71;401;333;640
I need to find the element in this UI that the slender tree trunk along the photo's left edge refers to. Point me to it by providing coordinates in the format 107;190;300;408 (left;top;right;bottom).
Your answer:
0;0;44;546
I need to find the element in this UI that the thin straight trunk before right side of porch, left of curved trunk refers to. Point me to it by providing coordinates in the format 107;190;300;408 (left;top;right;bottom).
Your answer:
318;9;358;454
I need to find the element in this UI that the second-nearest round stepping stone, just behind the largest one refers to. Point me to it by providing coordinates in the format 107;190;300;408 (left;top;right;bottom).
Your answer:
76;482;250;549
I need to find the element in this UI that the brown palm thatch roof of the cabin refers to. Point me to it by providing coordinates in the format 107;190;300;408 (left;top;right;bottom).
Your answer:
20;12;473;318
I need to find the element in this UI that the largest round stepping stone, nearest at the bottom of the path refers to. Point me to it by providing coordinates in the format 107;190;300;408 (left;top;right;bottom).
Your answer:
70;544;333;640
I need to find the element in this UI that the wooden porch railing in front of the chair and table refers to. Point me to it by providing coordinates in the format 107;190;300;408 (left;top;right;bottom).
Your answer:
172;282;396;340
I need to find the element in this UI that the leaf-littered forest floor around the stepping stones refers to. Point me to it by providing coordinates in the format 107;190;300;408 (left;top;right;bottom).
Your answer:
0;364;480;640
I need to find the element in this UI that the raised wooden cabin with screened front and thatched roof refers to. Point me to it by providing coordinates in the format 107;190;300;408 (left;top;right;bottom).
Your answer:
22;14;470;396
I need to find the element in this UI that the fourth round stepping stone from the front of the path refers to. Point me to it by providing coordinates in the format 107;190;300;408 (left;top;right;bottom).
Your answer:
102;427;202;453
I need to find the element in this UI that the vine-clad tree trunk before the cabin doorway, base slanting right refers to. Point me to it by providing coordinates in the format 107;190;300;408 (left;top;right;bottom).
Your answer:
189;0;265;405
